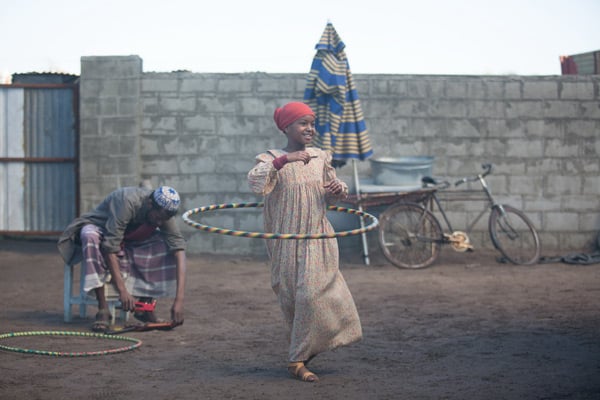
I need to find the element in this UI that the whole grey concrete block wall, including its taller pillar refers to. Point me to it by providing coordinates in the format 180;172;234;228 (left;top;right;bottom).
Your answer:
80;56;600;255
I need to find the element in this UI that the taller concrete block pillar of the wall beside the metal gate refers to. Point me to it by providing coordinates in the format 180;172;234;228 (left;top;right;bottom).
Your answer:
79;56;142;212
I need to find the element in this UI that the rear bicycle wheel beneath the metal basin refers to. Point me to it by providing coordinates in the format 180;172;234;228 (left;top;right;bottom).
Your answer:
379;203;443;269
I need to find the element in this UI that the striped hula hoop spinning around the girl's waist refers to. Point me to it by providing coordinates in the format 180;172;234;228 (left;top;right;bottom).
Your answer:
182;203;379;239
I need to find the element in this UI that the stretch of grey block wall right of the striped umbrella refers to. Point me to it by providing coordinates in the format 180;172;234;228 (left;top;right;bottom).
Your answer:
357;75;600;254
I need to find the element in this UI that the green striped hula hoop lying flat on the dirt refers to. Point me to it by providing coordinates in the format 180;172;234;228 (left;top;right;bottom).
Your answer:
0;331;142;357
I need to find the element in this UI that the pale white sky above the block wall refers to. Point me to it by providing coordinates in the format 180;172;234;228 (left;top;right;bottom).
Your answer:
0;0;600;83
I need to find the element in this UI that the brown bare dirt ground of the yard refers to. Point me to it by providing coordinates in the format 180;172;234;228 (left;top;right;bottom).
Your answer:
0;239;600;400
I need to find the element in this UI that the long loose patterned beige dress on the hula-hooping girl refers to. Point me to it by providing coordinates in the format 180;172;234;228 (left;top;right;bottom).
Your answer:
248;148;362;362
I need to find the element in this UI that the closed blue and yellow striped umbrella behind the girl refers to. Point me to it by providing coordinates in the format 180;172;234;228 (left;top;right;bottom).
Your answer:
304;22;373;166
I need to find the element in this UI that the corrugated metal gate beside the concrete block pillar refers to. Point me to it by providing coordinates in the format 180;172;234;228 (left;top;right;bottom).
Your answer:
0;84;79;236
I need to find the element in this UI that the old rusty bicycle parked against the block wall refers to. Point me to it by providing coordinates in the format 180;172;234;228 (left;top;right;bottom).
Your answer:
379;164;540;269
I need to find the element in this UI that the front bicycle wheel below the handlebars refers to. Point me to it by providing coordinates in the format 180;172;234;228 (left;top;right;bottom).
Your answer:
489;205;540;265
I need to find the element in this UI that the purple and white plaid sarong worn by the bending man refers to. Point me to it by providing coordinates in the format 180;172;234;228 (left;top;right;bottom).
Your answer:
81;225;177;297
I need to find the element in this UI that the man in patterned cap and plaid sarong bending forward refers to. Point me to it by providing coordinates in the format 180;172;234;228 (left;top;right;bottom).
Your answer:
58;186;186;332
